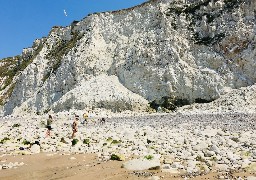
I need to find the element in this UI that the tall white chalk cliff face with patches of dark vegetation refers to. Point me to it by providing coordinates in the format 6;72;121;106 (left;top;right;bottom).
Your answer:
0;0;256;115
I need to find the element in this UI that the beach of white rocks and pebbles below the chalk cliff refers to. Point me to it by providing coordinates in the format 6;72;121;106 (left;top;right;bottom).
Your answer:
0;112;256;179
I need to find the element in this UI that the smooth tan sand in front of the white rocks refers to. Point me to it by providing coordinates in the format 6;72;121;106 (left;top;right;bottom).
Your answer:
0;153;256;180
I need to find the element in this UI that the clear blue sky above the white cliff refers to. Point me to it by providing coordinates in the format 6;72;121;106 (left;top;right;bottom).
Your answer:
0;0;147;59
